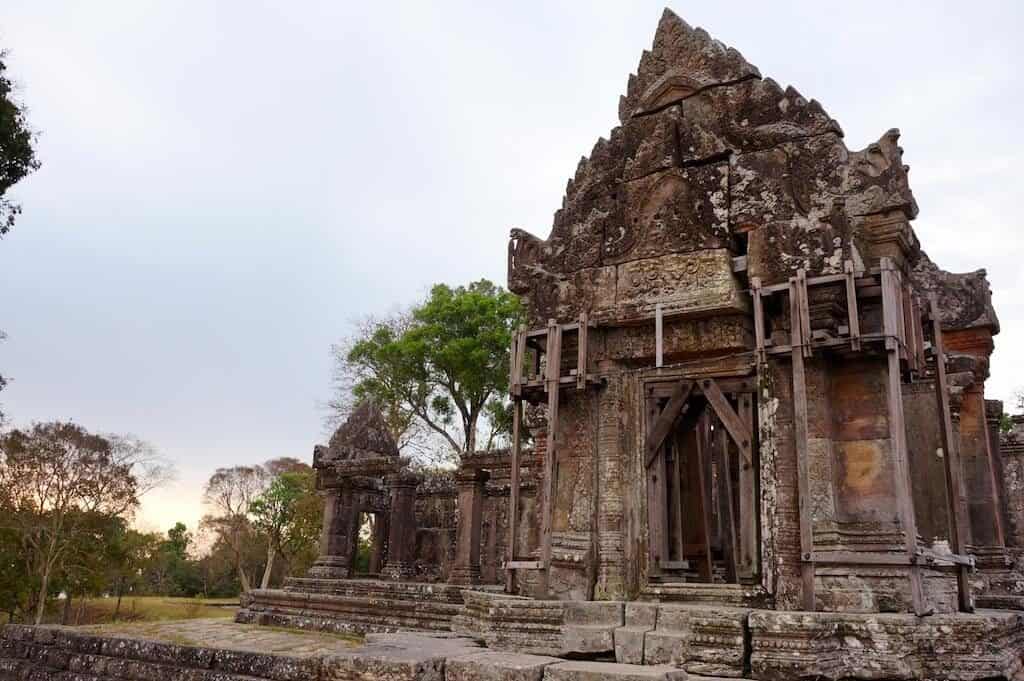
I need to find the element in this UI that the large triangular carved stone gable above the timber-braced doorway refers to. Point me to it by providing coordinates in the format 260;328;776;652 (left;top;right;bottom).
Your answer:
508;10;933;324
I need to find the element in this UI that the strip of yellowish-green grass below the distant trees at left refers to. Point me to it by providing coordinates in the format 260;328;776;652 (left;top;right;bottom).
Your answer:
0;596;239;625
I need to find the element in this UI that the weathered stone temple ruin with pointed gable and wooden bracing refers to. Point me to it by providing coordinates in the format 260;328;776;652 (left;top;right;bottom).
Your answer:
6;10;1024;681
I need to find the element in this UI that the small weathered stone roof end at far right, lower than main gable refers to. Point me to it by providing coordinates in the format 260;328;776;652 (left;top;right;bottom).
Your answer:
912;251;999;335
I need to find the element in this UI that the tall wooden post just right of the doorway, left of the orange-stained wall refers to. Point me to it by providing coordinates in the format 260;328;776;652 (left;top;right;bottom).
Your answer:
790;278;815;610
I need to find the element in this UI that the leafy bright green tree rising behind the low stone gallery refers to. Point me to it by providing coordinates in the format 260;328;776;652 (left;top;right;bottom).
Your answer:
333;280;520;457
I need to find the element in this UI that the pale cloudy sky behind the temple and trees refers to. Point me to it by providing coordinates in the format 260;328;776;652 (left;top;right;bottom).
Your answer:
0;0;1024;529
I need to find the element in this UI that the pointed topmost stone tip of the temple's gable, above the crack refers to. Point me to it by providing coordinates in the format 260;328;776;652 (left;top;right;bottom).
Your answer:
618;8;761;123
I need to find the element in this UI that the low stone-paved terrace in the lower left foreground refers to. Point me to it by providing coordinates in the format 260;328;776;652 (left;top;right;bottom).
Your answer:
0;620;720;681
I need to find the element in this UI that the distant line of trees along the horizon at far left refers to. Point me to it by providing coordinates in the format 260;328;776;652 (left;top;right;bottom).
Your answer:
0;422;322;624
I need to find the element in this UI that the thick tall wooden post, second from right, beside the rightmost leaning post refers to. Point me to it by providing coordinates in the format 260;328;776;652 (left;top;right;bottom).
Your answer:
882;258;930;615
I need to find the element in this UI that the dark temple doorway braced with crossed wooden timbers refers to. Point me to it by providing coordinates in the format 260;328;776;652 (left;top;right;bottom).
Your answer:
645;379;759;584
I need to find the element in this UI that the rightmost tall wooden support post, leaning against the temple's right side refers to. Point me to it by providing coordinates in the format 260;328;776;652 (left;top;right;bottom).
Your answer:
929;293;974;612
